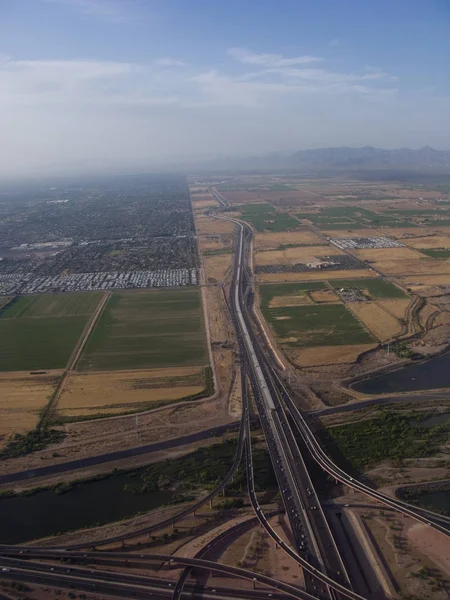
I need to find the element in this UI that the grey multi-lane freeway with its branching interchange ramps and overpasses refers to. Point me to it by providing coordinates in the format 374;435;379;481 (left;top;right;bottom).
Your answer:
0;209;450;600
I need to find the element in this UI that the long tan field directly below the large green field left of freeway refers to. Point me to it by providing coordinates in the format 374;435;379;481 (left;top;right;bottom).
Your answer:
56;367;206;421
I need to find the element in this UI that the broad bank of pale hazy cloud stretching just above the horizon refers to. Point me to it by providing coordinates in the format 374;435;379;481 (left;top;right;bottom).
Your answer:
0;53;444;173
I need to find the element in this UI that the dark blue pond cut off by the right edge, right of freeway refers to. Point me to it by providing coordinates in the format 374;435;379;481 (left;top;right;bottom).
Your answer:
350;352;450;394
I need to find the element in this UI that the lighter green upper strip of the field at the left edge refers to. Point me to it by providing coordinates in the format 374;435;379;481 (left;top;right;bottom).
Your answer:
0;292;103;319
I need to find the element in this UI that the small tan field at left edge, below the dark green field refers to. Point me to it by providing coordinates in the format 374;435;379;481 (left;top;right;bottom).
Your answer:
0;372;60;448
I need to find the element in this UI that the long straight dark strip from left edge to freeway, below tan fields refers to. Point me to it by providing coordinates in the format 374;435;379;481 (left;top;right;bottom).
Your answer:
0;421;239;484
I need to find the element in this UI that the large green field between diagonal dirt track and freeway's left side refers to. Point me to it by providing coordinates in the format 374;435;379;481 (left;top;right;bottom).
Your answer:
78;289;208;371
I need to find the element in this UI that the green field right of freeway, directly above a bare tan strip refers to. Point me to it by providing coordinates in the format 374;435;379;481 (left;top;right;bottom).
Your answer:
262;304;374;348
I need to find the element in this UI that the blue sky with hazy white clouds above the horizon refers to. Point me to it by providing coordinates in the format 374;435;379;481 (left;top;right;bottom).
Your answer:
0;0;450;176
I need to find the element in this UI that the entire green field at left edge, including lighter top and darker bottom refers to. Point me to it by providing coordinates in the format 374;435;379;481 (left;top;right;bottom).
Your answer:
0;292;103;371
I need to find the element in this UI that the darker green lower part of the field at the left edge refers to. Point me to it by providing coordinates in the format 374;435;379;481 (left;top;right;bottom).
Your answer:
0;315;88;371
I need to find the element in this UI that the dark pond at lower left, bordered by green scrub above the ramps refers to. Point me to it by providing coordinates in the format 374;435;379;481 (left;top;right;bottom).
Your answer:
0;473;175;544
